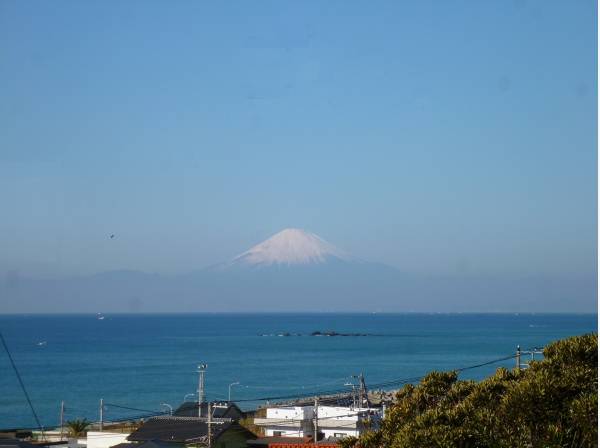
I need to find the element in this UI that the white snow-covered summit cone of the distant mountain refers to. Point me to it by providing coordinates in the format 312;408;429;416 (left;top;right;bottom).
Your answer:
231;229;352;266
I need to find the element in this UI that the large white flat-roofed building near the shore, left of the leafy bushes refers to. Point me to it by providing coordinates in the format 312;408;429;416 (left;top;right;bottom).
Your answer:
254;406;381;440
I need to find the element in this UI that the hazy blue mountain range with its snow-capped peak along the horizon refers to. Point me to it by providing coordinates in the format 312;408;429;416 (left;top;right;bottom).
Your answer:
0;228;597;313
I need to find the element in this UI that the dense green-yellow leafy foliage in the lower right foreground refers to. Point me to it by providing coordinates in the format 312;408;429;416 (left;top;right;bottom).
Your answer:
341;334;598;448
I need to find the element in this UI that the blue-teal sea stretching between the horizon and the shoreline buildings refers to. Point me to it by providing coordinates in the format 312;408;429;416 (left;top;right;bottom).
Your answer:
0;314;597;428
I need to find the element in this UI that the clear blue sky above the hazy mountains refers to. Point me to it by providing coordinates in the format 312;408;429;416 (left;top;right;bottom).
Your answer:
0;0;597;276
